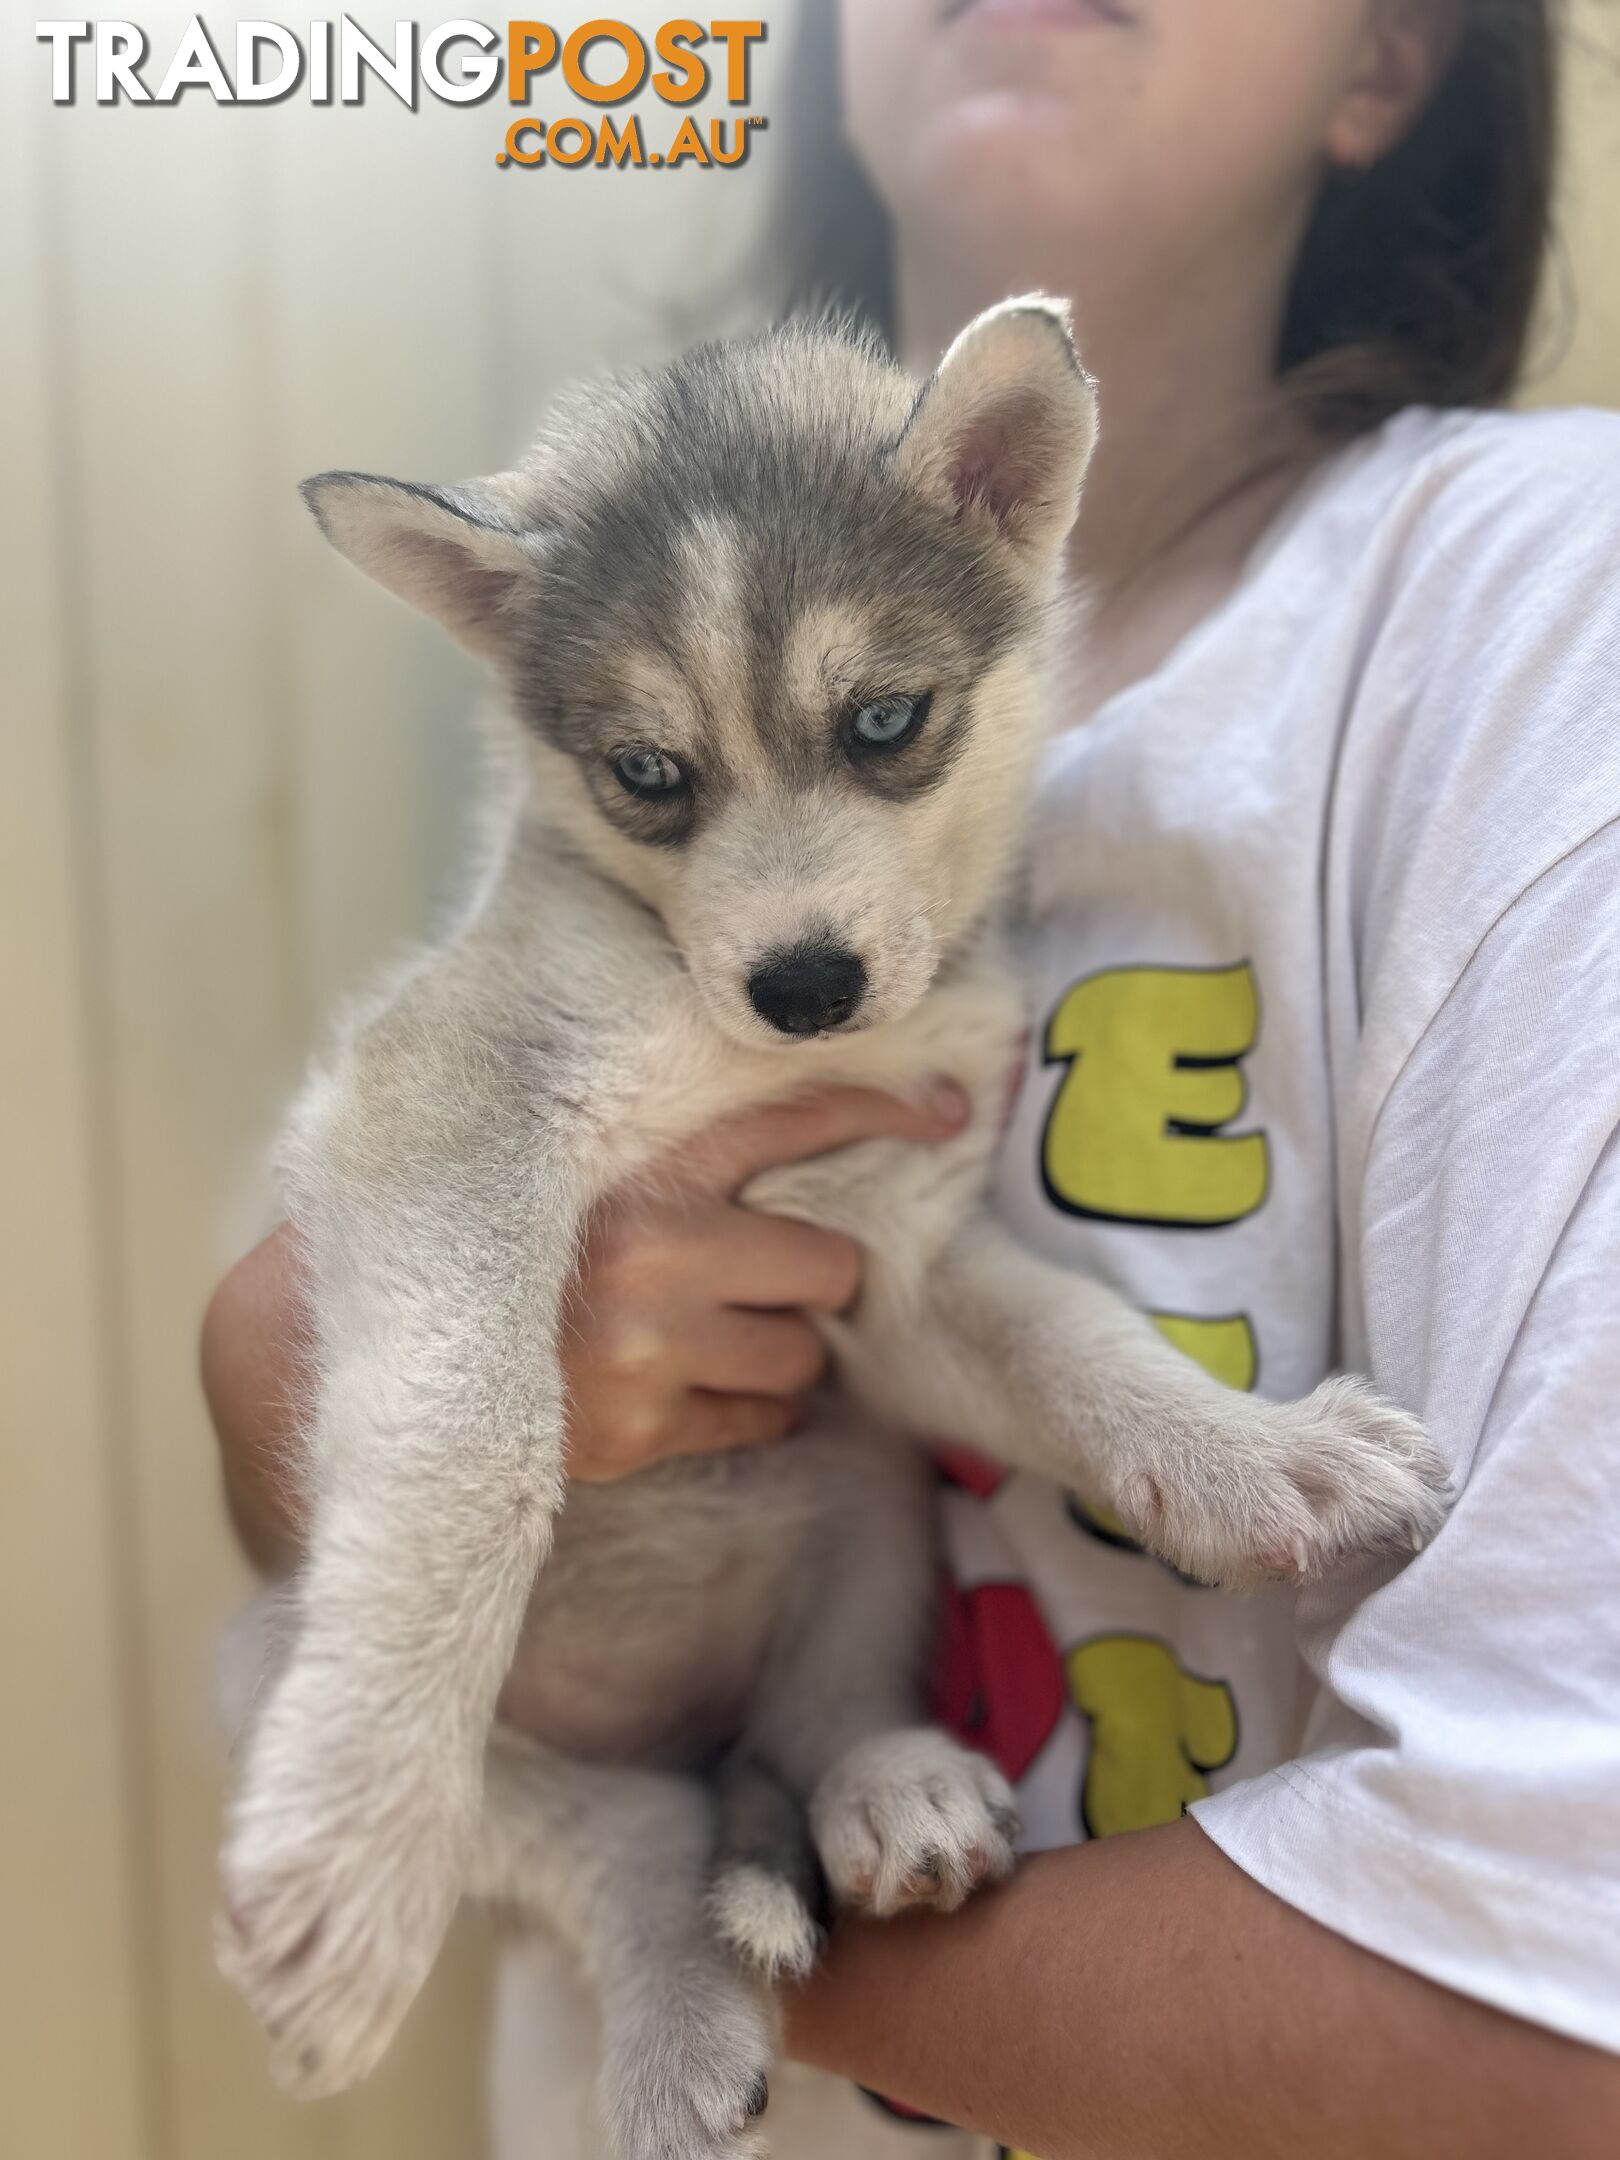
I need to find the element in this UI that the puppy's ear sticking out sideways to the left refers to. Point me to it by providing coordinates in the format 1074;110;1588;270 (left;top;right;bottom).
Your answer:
300;473;546;659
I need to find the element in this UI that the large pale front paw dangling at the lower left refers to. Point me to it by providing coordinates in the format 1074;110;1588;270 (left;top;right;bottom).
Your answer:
214;1698;471;2100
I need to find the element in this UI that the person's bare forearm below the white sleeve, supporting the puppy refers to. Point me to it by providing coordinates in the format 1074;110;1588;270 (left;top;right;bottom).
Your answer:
786;1821;1620;2160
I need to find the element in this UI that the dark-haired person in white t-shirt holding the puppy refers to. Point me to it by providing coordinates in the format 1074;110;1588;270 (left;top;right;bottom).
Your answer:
205;0;1620;2160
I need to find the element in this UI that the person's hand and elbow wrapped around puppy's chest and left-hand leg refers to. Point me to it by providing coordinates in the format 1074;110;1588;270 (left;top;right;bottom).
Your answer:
203;1084;968;1572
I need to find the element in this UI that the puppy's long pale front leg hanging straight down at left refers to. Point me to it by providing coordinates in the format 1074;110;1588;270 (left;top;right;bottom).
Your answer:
218;1061;579;2095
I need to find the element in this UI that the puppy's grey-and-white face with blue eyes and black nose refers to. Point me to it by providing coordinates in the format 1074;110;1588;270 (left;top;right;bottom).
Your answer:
514;494;1054;1043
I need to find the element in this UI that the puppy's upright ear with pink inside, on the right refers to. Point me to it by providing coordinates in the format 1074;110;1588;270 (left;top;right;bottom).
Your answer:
890;294;1097;562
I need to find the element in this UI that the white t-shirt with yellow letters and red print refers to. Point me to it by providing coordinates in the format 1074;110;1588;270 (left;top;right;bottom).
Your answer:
495;413;1620;2160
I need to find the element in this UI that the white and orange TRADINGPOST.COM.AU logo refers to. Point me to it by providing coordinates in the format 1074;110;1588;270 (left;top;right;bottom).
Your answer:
35;15;767;171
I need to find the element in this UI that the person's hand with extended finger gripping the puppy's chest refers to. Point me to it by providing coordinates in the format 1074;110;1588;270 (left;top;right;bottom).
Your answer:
562;1084;968;1482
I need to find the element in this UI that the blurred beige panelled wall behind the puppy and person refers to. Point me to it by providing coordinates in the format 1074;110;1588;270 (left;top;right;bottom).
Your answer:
0;12;1620;2160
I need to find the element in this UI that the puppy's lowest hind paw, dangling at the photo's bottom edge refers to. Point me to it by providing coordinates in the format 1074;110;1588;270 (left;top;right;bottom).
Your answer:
603;1950;773;2160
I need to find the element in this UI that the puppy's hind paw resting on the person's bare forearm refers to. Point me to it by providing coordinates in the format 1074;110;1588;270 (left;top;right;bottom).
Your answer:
810;1728;1017;1918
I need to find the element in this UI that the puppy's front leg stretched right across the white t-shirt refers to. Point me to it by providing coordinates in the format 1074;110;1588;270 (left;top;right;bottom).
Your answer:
851;1218;1445;1588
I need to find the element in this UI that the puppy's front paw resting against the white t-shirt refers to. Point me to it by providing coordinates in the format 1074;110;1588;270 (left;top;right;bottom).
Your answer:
1121;1378;1449;1590
